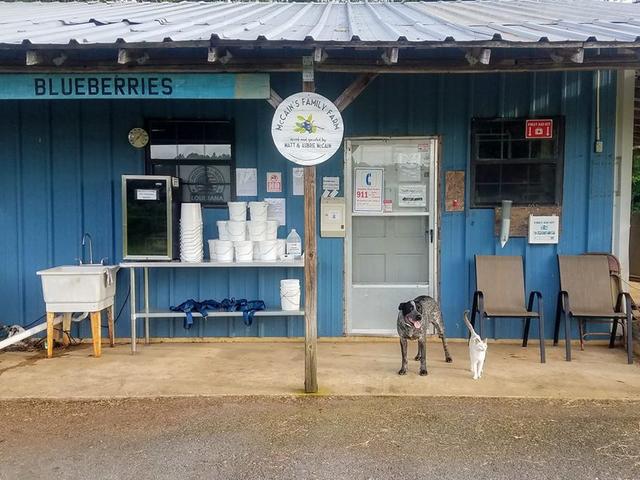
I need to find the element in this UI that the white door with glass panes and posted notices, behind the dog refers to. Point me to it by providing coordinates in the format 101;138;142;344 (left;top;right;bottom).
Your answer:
345;138;438;335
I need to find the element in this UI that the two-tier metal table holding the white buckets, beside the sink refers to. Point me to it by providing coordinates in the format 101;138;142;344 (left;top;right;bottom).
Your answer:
120;255;304;354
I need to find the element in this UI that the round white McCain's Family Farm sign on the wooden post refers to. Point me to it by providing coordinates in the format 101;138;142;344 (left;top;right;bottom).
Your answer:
271;92;344;166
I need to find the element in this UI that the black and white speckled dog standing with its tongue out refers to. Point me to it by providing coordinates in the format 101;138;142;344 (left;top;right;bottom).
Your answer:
398;295;453;375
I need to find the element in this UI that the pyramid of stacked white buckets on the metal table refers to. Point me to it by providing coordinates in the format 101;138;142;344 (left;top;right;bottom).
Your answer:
209;202;286;263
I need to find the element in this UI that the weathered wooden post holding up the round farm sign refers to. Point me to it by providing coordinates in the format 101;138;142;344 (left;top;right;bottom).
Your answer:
302;82;318;393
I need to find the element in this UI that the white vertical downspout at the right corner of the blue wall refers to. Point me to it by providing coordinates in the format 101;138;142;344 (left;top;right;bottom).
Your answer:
611;70;635;282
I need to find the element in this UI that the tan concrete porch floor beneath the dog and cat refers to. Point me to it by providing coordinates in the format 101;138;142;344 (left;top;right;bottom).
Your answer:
0;340;640;399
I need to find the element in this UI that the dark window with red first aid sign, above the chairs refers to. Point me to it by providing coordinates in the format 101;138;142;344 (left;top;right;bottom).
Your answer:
471;117;564;208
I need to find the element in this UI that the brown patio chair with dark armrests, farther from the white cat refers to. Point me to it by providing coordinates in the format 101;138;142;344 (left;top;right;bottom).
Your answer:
553;255;633;364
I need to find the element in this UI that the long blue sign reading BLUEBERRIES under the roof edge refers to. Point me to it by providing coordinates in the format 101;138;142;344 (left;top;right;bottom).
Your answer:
0;73;271;100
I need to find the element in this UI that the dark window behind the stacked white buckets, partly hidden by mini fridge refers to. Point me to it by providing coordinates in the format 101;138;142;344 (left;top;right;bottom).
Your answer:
147;120;235;207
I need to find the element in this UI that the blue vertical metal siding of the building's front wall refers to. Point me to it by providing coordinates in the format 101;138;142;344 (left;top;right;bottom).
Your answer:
0;72;615;338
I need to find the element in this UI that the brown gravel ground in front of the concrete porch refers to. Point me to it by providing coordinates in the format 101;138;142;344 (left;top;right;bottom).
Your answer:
0;397;640;480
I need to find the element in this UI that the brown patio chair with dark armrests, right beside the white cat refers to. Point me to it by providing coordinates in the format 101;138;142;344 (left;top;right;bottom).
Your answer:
471;255;546;363
